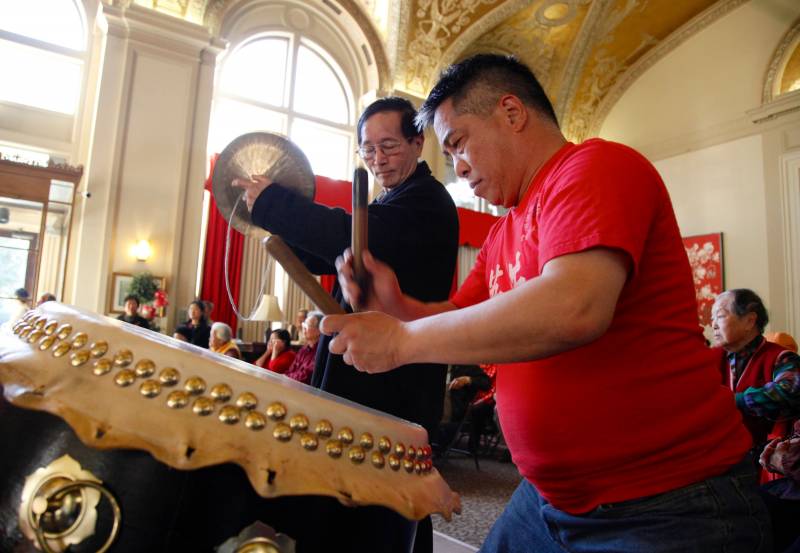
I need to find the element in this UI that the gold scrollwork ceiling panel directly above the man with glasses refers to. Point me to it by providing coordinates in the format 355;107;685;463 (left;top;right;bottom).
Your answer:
404;0;497;94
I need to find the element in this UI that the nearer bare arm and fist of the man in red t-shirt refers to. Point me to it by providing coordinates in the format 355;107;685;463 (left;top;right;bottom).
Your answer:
322;248;630;372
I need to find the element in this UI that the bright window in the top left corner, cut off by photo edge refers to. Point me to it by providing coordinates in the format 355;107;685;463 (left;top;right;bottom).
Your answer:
0;0;86;114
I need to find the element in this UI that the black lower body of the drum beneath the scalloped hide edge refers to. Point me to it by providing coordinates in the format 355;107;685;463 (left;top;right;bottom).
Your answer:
0;397;416;553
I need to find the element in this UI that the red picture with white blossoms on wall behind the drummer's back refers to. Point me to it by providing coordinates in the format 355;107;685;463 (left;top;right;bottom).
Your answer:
683;232;725;327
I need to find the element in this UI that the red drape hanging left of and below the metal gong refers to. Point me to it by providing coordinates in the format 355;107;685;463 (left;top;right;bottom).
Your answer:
200;154;244;333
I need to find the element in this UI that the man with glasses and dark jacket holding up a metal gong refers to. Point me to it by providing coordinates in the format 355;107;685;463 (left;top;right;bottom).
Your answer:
234;97;458;552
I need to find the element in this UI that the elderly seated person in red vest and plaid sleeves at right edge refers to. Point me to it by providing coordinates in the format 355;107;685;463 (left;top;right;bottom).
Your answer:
711;288;800;474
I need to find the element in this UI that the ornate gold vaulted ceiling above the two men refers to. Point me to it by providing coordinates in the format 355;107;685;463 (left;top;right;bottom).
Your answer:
134;0;752;140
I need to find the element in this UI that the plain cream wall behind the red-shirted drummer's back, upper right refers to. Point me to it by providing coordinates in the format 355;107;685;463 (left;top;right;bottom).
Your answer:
599;0;800;329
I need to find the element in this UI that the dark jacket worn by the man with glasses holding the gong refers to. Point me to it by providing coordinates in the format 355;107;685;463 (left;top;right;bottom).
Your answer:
252;162;458;433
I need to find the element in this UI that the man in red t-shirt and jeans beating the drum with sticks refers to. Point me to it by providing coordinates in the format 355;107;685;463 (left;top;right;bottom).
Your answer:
322;55;770;553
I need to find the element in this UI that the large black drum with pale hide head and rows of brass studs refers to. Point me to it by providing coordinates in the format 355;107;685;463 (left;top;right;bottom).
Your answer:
0;302;459;553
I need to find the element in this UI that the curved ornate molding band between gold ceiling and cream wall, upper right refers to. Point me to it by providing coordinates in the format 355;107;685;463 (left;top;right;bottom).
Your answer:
586;0;748;136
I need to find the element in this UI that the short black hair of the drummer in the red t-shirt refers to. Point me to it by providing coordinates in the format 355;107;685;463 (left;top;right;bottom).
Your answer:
416;54;558;129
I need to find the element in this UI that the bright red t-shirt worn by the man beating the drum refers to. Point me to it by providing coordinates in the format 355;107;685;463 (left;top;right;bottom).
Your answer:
452;139;750;513
